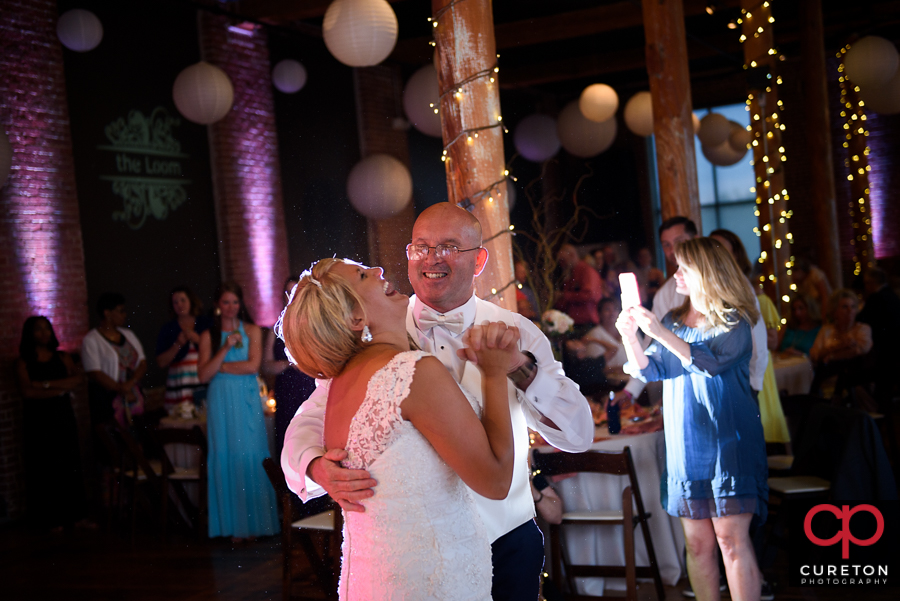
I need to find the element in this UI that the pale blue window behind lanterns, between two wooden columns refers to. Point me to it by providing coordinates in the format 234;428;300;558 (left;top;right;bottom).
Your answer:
694;104;759;262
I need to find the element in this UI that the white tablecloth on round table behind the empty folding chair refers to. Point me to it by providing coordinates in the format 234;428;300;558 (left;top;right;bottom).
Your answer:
548;431;684;595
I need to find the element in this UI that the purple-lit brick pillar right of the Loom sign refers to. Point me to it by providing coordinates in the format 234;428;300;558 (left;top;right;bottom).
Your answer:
200;11;289;326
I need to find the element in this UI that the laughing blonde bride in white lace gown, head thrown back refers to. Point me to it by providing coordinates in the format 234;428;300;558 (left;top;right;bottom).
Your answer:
276;259;519;601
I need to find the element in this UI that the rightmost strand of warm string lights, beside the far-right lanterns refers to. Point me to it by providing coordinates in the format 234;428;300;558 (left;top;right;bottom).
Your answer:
837;44;875;276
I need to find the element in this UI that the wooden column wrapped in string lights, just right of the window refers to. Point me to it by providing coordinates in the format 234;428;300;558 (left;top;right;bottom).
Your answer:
739;0;793;315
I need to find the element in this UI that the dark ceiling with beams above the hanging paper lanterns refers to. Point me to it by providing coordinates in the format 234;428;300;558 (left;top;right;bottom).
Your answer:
216;0;900;107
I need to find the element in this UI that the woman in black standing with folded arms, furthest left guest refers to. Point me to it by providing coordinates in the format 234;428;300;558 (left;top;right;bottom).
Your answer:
16;316;93;532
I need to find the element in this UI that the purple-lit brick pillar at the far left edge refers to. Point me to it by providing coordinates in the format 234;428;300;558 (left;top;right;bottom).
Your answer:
0;0;88;518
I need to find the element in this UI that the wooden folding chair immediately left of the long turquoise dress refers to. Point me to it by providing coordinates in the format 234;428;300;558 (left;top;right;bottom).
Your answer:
153;426;209;538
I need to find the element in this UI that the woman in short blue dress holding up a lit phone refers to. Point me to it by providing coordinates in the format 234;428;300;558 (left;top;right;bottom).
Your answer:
616;238;768;601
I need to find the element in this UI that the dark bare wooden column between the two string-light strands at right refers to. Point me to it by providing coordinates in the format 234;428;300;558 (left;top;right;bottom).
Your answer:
800;0;843;288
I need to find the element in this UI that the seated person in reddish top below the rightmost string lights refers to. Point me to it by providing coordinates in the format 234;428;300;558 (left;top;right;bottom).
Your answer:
809;288;872;398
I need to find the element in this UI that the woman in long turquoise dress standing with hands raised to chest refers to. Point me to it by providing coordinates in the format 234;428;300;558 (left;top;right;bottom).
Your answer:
198;283;278;542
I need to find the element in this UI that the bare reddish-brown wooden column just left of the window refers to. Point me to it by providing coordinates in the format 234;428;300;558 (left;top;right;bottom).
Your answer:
643;0;701;229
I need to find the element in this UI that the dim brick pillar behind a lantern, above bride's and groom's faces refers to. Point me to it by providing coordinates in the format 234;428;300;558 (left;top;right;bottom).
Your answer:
353;65;415;294
